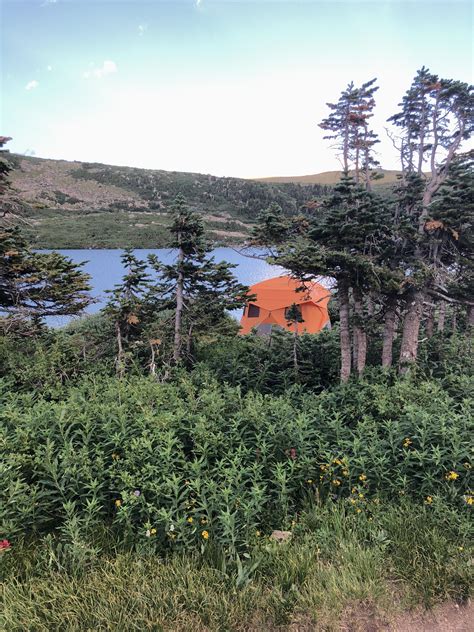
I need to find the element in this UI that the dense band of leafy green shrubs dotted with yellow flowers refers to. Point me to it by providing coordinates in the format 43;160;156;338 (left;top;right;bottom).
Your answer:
0;371;473;563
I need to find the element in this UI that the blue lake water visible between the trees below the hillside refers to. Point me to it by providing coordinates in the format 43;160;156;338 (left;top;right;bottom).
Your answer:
48;248;284;327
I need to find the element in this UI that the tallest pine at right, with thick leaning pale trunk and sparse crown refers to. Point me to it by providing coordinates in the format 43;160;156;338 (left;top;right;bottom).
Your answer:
389;67;474;372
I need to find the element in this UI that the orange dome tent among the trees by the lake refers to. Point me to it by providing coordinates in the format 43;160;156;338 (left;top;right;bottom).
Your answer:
240;276;330;335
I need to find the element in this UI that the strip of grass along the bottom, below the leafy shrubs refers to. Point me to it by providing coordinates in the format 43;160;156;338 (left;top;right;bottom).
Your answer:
0;502;472;632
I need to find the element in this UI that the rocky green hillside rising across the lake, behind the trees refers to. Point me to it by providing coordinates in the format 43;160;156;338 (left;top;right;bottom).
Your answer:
9;154;327;248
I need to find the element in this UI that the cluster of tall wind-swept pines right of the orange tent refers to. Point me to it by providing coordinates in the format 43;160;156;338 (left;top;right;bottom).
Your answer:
254;68;474;381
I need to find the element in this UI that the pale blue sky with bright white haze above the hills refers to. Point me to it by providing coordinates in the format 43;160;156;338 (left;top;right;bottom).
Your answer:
0;0;473;178
